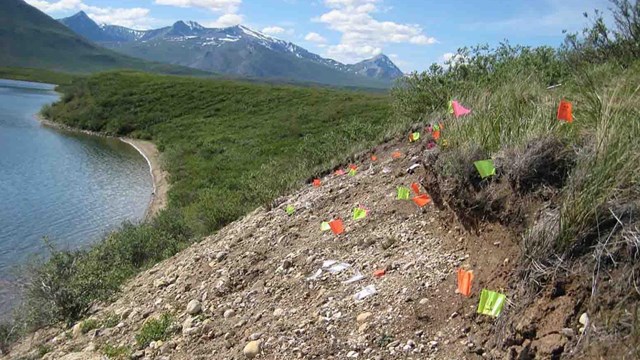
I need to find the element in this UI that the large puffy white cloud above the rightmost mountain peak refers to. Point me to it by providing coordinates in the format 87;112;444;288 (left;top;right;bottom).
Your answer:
314;0;437;62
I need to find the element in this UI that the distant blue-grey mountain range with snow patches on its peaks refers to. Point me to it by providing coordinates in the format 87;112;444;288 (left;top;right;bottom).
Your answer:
59;11;403;87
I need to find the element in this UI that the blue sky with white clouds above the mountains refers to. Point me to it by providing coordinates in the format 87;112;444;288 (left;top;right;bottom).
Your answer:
25;0;610;72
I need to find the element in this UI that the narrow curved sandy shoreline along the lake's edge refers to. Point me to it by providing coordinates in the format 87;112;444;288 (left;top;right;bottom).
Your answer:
35;113;169;221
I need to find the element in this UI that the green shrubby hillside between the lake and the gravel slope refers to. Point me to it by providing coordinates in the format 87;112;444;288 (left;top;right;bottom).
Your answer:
0;72;405;337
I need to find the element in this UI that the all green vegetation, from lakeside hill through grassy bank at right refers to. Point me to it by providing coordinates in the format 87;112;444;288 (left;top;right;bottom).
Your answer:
0;0;640;352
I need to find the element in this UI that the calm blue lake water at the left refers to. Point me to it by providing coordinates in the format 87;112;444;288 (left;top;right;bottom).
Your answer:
0;79;153;317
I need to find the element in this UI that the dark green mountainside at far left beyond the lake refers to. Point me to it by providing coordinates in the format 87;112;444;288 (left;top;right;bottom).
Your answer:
0;0;208;75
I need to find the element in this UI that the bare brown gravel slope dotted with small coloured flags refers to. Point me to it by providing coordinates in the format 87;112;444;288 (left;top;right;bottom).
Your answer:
3;141;515;360
